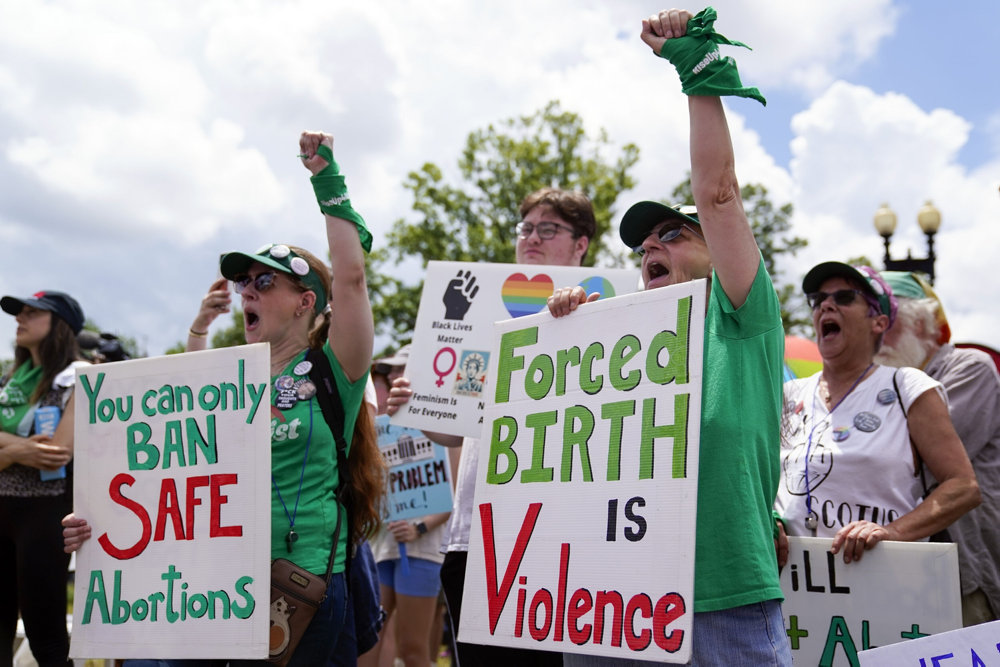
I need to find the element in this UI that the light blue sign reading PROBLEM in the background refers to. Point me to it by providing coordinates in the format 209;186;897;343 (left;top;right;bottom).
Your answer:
375;415;453;521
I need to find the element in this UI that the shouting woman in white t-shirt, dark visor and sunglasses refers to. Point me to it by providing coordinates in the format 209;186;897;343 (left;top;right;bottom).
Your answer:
775;262;980;564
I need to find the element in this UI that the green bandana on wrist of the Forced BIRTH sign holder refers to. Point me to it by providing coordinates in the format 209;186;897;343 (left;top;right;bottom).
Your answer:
660;7;767;106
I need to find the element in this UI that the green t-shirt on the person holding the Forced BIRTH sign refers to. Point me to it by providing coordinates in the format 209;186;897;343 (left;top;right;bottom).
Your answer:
694;261;785;612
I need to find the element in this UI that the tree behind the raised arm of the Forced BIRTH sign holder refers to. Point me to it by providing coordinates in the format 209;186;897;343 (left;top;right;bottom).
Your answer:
668;177;812;335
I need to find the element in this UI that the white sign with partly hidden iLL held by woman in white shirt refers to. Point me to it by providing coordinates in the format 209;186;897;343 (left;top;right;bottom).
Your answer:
781;537;962;666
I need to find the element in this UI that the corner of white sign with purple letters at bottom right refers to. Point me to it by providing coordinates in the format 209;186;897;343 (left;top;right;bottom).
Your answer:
858;621;1000;667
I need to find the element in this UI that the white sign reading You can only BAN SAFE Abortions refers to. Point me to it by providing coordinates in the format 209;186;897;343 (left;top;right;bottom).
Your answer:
70;344;271;659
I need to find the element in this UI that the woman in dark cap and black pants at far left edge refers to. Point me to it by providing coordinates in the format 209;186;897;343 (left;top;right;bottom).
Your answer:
0;290;86;665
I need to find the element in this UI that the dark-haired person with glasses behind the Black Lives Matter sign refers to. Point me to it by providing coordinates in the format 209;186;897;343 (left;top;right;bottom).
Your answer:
388;188;597;667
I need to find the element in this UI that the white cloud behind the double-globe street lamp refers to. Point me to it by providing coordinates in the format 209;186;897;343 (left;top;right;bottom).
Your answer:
791;82;1000;344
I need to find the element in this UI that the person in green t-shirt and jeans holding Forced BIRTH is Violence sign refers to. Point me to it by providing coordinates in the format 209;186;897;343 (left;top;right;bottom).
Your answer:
549;8;792;667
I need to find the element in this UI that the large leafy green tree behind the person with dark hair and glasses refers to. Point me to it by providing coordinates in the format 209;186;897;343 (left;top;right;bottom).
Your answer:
368;101;639;344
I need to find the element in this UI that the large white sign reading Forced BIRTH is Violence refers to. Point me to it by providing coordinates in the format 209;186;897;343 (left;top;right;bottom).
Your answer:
459;280;705;663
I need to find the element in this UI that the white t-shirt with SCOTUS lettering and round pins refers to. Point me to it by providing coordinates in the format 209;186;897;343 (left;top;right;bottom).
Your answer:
775;366;946;537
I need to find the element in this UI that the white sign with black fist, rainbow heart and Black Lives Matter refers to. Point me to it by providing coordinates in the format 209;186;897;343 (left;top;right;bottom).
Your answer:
392;262;639;437
